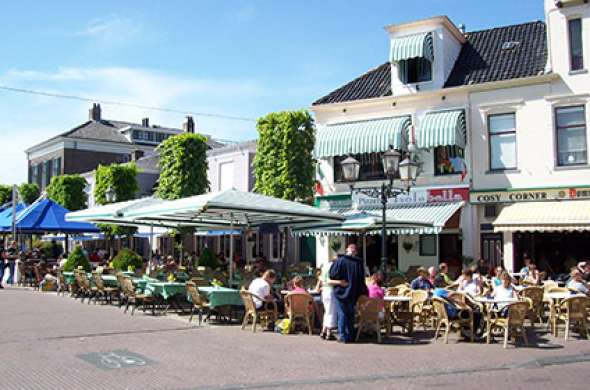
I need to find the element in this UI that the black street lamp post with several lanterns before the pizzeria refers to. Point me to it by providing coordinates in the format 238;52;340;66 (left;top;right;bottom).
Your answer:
340;144;419;275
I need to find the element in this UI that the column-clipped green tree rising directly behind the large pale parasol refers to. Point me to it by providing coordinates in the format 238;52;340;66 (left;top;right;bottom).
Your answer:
157;133;209;199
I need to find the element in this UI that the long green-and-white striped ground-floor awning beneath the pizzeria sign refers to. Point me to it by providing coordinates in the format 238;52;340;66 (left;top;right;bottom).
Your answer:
293;202;464;236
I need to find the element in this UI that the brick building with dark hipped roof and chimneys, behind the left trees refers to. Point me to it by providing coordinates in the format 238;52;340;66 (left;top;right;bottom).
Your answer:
25;103;221;189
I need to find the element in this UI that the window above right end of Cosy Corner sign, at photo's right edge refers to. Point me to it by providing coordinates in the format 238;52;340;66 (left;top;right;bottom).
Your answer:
555;106;587;166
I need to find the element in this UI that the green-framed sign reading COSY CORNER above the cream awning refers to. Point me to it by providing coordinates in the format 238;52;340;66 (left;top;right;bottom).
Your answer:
469;187;590;204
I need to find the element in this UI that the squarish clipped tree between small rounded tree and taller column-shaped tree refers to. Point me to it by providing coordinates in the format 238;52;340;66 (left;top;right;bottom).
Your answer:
94;163;139;237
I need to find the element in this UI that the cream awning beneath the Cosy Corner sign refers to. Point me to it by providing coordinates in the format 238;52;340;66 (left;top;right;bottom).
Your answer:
493;200;590;232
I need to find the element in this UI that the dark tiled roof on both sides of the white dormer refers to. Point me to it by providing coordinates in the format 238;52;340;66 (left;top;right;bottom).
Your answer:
313;21;547;105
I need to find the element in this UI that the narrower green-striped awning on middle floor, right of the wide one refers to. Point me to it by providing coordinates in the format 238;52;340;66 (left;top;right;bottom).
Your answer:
417;110;466;149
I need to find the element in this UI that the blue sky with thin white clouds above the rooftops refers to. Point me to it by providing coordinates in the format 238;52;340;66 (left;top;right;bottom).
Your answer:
0;0;543;184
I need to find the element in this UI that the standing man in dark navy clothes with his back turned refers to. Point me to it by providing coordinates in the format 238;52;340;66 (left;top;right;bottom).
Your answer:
330;244;368;343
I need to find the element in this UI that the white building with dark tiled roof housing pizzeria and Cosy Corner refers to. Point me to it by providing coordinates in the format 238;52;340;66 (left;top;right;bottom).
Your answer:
304;0;590;272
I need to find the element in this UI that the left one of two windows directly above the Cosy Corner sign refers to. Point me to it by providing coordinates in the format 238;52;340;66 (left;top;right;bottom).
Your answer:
488;113;516;171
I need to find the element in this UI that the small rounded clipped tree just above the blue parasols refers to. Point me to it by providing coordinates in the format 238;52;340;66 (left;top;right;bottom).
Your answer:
46;175;88;211
